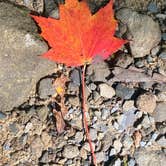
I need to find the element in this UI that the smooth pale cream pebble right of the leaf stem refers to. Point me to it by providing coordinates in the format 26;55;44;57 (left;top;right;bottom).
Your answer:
99;83;115;99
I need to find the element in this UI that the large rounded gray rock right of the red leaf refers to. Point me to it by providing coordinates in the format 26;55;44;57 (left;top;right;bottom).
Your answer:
116;8;161;58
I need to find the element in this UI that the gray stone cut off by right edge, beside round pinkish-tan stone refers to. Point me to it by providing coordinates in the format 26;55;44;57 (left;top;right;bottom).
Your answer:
154;102;166;122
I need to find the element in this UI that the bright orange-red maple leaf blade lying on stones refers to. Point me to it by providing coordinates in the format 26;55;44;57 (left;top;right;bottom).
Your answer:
32;0;126;66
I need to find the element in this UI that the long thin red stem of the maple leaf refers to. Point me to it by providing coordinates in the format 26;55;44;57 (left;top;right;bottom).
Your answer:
82;64;97;166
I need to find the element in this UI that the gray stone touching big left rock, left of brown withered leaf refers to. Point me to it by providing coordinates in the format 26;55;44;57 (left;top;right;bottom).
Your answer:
38;78;55;99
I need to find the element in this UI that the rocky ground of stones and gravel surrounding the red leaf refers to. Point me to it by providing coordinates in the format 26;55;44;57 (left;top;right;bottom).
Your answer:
0;0;166;166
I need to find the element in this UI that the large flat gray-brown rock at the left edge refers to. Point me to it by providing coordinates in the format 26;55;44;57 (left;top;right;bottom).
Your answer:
0;1;55;112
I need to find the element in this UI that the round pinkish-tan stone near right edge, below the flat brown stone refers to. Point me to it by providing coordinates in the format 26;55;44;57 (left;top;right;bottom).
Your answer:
136;93;156;113
